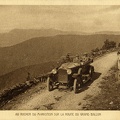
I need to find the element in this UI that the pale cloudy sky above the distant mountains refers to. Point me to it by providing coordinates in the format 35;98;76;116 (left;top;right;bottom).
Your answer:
0;5;120;33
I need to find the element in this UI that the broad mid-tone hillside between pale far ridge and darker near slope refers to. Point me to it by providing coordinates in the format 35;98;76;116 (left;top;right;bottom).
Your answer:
0;35;120;75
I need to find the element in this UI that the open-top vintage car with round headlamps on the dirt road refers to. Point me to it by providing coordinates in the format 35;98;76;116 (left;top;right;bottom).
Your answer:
47;60;94;93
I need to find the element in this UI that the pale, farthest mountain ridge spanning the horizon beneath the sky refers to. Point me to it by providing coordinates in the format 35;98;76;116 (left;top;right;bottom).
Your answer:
0;28;120;47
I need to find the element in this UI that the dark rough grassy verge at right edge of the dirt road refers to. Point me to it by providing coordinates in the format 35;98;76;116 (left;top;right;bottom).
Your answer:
83;65;120;110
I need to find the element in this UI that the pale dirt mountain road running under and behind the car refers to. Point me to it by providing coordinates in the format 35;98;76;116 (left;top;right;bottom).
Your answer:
2;52;117;110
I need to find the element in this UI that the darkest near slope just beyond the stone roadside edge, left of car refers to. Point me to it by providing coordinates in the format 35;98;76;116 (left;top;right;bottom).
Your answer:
0;62;56;92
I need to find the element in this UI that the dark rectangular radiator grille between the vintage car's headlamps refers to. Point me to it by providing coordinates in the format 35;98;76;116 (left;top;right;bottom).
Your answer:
58;69;68;83
